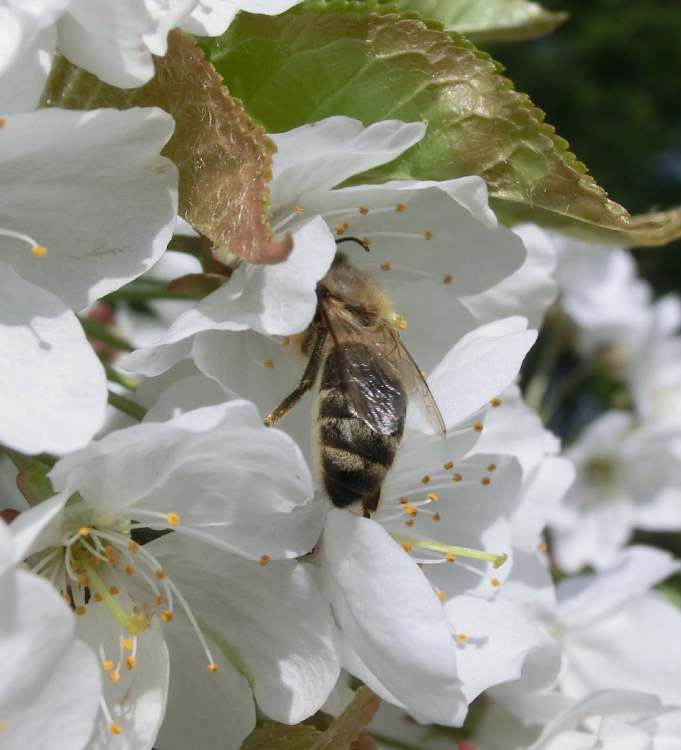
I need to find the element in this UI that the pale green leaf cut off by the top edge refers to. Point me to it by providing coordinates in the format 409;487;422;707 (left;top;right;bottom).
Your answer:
303;0;568;43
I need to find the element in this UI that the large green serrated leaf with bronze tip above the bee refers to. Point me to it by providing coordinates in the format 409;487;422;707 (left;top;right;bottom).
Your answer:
203;8;681;244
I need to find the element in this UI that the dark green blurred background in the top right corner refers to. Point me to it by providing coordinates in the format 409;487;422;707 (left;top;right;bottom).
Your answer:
489;0;681;293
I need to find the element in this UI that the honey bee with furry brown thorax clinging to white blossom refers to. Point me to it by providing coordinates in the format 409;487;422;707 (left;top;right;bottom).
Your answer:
265;237;445;518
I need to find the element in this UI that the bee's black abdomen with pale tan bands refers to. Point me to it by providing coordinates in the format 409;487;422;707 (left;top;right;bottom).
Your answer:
317;344;407;511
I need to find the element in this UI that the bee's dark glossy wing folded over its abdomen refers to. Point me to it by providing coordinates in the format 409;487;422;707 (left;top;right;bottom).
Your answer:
322;303;407;435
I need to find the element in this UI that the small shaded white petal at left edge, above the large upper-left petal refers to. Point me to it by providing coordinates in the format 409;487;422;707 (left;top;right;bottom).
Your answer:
0;25;57;115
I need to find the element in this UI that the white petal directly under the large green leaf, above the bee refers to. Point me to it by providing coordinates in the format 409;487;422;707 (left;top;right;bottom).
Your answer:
270;117;426;208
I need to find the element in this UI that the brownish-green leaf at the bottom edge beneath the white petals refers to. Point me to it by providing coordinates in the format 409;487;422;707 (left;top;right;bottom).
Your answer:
241;687;381;750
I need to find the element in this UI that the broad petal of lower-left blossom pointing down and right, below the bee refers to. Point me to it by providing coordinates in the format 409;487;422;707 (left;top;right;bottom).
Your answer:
149;534;340;724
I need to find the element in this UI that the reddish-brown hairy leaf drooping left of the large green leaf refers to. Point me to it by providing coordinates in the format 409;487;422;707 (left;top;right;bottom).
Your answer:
43;30;291;263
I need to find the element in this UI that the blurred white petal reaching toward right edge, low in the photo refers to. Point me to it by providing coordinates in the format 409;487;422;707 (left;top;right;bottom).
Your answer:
558;546;681;627
